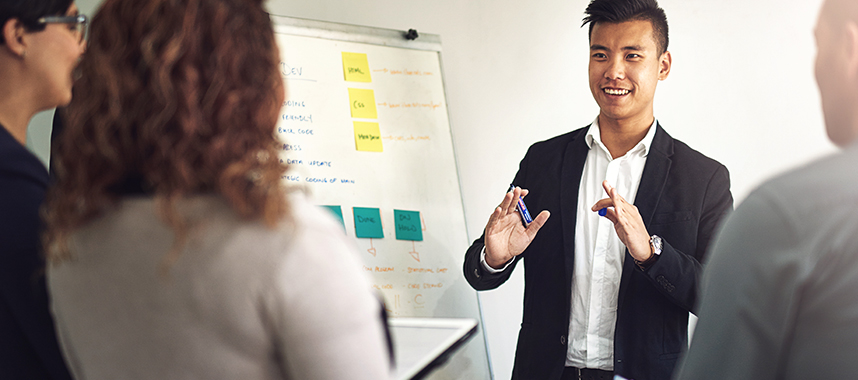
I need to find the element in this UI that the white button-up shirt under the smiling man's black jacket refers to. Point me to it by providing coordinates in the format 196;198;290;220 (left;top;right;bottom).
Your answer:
480;117;656;371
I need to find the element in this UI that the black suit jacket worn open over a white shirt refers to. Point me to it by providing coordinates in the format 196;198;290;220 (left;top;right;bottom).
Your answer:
464;126;733;380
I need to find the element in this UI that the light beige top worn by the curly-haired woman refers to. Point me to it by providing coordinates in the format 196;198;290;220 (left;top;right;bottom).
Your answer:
48;195;390;380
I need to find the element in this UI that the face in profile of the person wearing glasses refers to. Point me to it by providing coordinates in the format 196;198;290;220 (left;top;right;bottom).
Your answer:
27;3;86;108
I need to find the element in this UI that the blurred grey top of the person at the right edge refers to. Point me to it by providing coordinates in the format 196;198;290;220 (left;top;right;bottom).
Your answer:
677;146;858;380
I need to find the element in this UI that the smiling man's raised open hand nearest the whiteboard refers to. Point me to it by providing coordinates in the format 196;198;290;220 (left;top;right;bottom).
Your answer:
485;187;550;269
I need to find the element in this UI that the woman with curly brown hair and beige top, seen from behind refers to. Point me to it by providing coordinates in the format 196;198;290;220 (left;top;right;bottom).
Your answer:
45;0;390;379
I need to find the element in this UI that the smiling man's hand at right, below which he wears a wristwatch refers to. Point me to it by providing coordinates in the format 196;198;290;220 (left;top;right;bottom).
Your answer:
591;181;653;261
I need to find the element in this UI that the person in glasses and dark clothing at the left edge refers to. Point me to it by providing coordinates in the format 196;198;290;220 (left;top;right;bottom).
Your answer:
0;0;86;379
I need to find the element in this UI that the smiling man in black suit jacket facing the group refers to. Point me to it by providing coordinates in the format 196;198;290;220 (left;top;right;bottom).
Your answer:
464;0;733;380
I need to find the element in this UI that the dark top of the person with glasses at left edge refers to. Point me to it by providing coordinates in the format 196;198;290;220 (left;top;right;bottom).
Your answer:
0;125;71;380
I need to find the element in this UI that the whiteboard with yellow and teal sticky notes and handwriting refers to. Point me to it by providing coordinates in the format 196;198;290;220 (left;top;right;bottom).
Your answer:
272;16;490;379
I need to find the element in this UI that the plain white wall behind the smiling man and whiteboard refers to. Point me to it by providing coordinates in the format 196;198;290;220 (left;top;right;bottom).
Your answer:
31;0;833;379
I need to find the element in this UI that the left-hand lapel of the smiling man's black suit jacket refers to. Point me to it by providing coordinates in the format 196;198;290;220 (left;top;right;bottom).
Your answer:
560;128;590;299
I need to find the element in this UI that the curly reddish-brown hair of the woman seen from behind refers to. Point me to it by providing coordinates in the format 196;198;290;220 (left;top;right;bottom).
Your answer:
44;0;288;264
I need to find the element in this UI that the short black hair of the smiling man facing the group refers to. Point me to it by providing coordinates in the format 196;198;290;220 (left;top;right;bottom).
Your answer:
581;0;669;54
